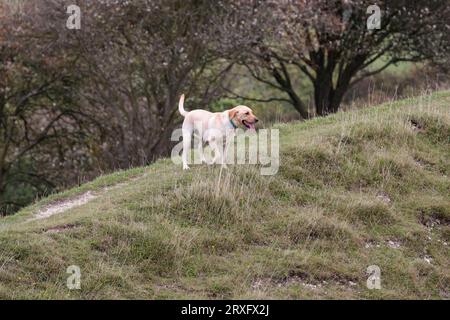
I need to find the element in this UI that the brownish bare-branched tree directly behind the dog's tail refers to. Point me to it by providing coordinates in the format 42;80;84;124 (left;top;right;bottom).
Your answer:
69;0;246;168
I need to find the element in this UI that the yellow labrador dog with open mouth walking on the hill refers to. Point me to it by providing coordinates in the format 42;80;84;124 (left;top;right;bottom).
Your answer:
178;94;259;170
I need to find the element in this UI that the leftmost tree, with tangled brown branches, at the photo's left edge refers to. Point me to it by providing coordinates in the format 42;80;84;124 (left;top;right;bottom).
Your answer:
0;0;90;215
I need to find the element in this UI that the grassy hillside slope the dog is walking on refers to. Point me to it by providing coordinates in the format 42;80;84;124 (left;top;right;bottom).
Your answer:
0;92;450;299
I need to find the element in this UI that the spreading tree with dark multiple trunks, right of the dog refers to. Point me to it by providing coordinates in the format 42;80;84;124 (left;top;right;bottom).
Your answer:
234;0;450;118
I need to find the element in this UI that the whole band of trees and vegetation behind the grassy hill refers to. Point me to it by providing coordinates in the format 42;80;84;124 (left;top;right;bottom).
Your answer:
0;0;450;215
